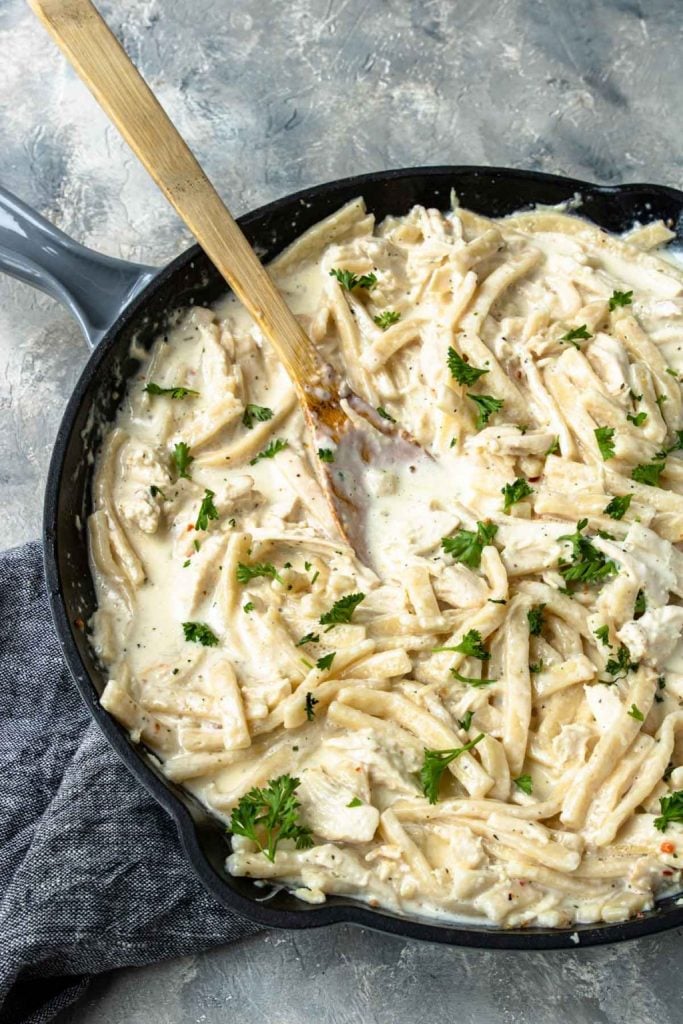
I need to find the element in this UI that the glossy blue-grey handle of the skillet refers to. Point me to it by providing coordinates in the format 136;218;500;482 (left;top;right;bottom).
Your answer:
0;185;157;348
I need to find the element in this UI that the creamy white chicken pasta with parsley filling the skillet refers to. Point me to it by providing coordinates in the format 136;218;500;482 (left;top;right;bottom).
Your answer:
89;200;683;928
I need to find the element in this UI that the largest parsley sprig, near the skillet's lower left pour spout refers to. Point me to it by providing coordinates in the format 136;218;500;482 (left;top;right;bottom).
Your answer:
230;775;313;861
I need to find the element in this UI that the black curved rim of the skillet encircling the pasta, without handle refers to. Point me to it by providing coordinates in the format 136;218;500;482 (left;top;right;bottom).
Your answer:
43;165;683;950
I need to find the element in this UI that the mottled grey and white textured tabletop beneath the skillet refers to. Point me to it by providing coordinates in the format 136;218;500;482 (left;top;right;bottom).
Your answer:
0;0;683;1024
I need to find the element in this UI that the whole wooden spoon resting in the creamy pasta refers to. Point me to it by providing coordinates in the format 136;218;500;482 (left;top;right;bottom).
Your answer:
29;0;430;562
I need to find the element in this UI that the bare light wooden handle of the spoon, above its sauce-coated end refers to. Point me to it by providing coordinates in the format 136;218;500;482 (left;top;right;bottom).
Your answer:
29;0;324;392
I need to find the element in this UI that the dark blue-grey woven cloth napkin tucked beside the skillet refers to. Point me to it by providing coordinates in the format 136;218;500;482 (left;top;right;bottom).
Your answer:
0;544;259;1024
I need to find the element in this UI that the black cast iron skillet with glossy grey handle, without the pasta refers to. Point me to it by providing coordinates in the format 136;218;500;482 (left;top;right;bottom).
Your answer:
5;167;683;949
